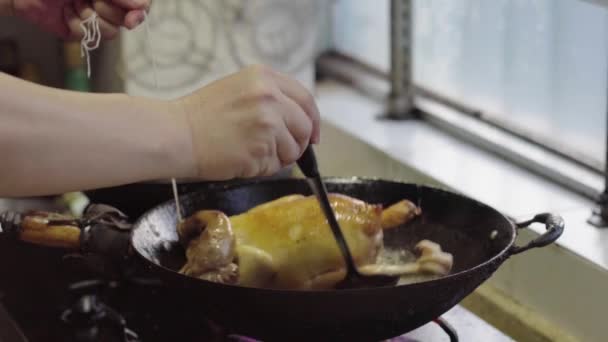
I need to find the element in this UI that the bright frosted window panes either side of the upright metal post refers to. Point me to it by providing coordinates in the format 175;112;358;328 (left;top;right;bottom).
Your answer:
333;0;608;188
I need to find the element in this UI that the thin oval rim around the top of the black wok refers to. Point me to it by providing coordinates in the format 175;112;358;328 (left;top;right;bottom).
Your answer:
130;176;518;296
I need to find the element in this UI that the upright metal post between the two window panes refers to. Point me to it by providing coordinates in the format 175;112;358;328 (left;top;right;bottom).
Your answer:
384;0;414;120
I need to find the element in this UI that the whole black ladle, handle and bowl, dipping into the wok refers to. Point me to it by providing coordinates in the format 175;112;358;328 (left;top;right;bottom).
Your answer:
297;145;399;289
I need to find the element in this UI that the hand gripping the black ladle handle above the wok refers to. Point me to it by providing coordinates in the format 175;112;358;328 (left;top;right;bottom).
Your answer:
174;66;320;180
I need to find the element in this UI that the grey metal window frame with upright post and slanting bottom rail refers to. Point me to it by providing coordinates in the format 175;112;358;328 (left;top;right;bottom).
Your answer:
317;0;608;227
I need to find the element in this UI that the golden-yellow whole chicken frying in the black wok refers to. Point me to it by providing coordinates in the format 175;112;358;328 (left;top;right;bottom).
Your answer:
177;193;452;289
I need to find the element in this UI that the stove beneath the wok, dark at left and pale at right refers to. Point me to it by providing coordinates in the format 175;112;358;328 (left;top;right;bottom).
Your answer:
0;201;513;342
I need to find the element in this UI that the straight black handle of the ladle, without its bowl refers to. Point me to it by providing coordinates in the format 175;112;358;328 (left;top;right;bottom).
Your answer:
297;145;359;276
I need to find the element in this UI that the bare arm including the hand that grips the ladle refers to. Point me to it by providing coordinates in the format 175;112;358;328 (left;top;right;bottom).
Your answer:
0;66;320;197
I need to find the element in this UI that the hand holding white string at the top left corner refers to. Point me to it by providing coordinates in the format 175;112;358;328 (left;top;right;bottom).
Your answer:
12;0;151;40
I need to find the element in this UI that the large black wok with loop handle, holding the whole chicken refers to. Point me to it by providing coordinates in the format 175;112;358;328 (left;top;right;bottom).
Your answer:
0;178;564;341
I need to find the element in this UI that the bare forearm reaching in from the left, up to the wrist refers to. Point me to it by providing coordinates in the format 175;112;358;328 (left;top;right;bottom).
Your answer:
0;74;194;196
